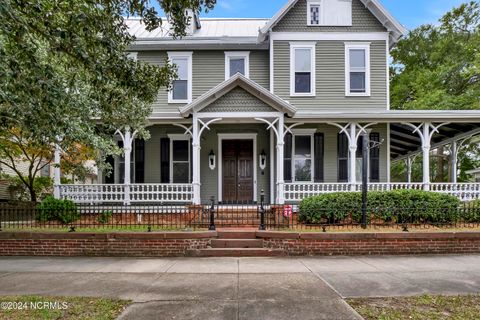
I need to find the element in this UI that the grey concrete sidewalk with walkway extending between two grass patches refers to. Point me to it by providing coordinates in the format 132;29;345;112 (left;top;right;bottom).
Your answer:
0;256;480;320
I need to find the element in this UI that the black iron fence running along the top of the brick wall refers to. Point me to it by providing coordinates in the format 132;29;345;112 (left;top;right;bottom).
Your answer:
0;197;480;232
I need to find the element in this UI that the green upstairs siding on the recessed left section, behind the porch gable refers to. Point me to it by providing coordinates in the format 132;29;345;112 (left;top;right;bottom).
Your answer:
137;49;270;113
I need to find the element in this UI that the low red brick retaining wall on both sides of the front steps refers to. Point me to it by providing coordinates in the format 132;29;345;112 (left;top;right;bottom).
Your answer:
0;231;480;257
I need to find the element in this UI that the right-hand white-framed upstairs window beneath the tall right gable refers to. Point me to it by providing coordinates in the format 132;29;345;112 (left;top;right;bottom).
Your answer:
345;43;370;96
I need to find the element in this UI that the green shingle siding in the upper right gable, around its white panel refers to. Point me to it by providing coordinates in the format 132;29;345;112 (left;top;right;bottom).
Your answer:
273;0;387;32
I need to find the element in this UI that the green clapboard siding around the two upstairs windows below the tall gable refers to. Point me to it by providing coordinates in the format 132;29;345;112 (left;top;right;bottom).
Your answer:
274;41;387;111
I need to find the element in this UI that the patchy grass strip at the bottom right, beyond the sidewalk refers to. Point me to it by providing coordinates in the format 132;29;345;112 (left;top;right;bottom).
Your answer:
347;295;480;320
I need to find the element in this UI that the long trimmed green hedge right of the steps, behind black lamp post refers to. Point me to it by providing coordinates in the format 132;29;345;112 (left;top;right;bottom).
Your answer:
299;190;460;224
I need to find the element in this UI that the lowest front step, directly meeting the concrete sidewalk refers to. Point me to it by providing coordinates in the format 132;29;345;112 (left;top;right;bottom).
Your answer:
187;248;285;257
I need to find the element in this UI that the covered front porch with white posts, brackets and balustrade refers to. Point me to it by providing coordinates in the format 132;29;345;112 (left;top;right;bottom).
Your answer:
55;75;480;205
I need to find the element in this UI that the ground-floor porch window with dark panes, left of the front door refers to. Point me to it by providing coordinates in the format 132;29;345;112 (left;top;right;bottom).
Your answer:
169;135;191;183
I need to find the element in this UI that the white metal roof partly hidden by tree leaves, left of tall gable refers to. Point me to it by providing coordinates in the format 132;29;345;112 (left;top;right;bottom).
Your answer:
126;18;268;40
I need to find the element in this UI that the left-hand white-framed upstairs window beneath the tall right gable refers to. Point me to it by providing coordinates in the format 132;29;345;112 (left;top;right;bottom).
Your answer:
290;43;315;97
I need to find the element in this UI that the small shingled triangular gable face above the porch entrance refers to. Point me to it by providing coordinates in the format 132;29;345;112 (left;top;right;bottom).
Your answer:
202;87;277;112
